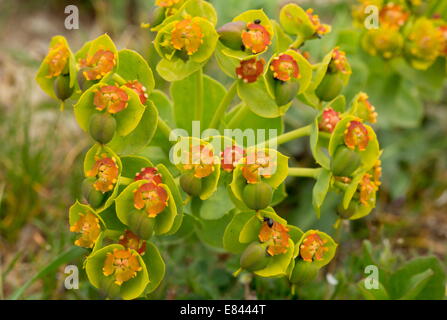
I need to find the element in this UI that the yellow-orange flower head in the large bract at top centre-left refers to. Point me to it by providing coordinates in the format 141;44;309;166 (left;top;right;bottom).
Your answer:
171;19;204;55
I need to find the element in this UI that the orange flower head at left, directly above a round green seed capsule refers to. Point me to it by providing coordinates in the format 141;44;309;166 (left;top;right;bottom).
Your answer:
93;85;129;114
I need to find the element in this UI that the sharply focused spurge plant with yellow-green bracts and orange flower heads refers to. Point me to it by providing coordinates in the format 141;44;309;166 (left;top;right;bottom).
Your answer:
37;0;384;299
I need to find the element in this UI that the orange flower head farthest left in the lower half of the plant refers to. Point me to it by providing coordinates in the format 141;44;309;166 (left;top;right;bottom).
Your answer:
70;212;101;248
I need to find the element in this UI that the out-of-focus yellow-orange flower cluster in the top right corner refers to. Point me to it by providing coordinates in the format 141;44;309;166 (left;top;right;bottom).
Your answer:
353;0;447;70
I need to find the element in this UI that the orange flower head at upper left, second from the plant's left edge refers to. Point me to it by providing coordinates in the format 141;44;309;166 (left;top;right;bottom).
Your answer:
79;49;116;80
